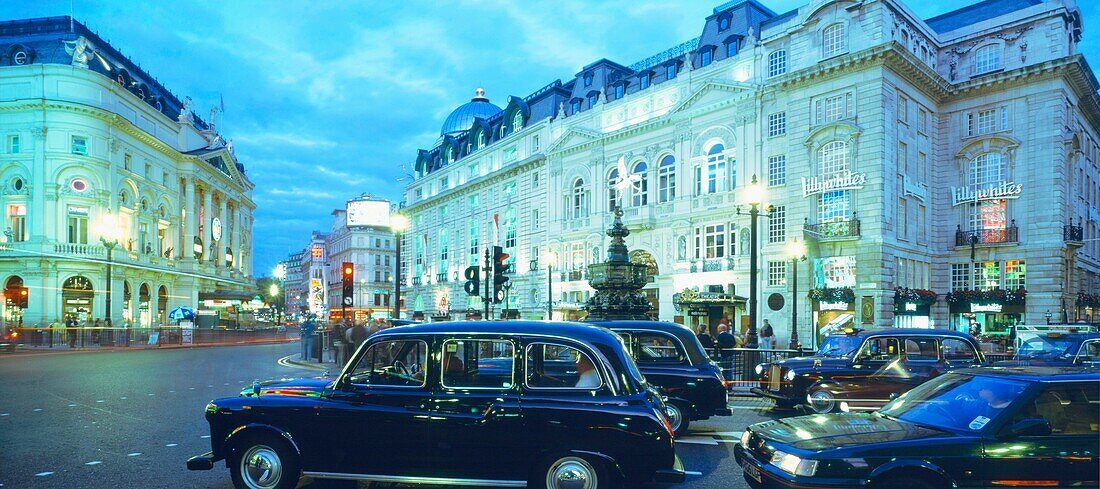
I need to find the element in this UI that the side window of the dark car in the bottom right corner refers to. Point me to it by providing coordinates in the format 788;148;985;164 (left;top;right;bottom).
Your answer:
1012;382;1100;438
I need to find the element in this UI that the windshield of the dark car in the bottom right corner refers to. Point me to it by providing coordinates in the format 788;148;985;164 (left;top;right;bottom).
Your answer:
879;374;1027;433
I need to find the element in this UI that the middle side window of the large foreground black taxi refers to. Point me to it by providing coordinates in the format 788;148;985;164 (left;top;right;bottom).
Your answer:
440;340;515;389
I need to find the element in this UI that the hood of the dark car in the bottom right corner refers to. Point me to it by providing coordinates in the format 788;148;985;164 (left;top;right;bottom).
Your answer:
752;413;946;452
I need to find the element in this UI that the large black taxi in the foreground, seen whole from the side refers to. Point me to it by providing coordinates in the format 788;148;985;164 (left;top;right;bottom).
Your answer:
187;321;684;489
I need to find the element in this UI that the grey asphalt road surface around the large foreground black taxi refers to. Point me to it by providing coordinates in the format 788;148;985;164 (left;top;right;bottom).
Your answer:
0;343;792;489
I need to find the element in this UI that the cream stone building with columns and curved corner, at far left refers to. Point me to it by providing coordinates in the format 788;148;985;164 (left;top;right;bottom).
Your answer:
0;18;255;326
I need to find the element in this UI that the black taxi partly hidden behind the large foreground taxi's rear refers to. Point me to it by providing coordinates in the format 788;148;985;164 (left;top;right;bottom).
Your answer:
593;321;733;435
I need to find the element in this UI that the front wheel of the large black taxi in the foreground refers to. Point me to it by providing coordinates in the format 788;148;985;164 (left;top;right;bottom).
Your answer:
229;433;301;489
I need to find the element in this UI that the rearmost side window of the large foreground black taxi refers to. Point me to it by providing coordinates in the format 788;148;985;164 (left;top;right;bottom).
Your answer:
524;343;604;390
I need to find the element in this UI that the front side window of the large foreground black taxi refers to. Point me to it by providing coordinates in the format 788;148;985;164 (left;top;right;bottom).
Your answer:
348;340;428;387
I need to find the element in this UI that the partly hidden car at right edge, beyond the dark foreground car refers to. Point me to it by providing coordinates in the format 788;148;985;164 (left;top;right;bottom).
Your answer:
994;331;1100;367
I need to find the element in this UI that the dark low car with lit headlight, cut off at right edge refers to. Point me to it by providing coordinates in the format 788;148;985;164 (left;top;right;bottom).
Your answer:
734;367;1100;489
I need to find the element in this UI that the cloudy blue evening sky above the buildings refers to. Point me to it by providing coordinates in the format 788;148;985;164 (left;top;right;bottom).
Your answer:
0;0;1100;276
